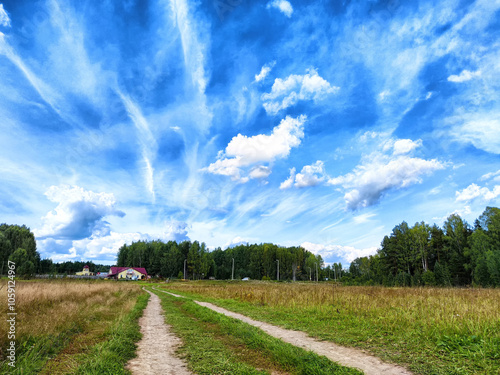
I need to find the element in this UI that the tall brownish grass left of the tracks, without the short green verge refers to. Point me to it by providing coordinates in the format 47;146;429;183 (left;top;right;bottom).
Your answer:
0;280;141;374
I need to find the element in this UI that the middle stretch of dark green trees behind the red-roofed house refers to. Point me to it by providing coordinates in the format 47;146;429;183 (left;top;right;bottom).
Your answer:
117;241;328;281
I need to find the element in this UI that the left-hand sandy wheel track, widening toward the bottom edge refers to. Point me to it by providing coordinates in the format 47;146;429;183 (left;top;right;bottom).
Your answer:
127;290;192;375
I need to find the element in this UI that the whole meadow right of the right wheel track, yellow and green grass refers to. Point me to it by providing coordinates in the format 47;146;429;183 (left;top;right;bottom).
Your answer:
160;281;500;375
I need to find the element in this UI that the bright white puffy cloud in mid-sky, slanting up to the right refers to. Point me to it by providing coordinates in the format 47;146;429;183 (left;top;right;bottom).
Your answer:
203;115;307;183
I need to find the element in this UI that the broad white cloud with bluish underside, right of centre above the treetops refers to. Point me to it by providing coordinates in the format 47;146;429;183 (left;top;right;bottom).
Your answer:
328;140;445;210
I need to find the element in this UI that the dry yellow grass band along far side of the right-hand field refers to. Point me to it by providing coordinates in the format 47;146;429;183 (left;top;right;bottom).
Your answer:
164;282;500;326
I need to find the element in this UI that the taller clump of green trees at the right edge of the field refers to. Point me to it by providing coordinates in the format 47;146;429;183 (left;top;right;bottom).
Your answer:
346;207;500;287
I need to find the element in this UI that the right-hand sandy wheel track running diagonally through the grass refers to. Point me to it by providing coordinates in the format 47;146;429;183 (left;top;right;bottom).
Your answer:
152;289;412;375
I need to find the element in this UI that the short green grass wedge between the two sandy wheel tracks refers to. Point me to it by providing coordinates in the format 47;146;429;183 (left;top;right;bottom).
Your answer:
150;293;360;375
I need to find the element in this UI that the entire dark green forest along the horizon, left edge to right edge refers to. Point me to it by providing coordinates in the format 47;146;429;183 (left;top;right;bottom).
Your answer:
0;207;500;287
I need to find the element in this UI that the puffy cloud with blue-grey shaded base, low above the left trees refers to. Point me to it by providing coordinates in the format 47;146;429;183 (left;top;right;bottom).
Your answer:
35;185;125;240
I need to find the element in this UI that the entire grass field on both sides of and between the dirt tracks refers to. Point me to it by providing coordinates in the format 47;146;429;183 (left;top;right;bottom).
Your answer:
0;280;500;375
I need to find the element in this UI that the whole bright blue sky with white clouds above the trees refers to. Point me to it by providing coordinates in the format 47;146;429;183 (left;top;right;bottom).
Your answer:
0;0;500;265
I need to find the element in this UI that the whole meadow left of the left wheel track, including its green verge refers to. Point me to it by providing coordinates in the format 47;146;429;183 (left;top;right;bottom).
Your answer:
0;280;148;375
